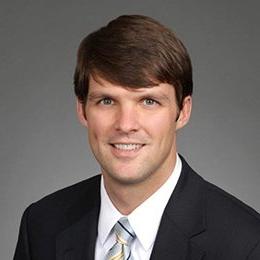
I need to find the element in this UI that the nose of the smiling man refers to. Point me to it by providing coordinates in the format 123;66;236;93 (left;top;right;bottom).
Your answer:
115;105;140;133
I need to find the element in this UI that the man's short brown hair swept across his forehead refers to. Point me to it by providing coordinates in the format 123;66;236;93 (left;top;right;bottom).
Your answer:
74;15;193;108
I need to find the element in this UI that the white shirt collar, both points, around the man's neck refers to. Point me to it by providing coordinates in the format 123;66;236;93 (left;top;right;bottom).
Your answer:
98;154;182;250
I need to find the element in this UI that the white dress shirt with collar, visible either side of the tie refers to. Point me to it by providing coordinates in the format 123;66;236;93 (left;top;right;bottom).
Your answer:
95;154;182;260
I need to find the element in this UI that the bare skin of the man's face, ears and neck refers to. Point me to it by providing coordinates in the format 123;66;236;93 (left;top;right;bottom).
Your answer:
77;74;192;215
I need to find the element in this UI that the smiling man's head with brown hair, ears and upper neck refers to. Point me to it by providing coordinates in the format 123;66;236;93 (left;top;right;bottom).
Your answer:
75;16;192;197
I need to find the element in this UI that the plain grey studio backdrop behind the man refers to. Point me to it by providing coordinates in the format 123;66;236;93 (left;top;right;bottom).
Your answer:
0;0;260;259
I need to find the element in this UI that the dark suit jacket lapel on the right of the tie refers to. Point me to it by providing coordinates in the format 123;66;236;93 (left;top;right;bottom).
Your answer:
150;158;206;260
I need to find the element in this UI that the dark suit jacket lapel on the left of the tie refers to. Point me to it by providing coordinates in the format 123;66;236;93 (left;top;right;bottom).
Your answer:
56;178;100;260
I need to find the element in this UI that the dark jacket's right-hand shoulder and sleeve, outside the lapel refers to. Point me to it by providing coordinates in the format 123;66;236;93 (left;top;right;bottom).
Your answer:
183;157;260;260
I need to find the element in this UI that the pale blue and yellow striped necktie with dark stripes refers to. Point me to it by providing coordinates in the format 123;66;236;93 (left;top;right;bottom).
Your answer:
106;217;135;260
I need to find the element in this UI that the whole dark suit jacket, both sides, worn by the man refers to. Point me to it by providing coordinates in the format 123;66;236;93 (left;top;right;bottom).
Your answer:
14;155;260;260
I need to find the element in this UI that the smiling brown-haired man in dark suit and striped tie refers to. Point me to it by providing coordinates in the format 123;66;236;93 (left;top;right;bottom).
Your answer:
14;15;260;260
